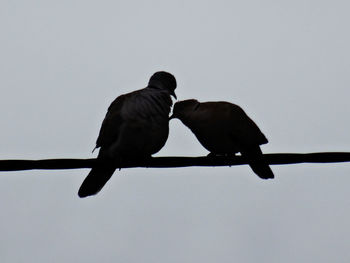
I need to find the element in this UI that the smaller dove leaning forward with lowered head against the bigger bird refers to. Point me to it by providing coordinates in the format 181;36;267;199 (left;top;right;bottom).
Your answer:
170;99;274;179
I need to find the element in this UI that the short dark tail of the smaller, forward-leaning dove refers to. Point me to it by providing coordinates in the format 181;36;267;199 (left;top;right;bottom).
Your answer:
241;146;275;179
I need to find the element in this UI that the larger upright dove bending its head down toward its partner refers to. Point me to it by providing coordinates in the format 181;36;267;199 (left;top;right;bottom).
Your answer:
78;71;176;197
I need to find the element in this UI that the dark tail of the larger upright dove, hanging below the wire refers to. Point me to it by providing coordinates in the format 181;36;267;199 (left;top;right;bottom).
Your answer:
78;165;116;198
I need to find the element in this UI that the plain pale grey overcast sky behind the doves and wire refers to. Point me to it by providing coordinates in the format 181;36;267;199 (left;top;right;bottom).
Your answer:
0;0;350;263
